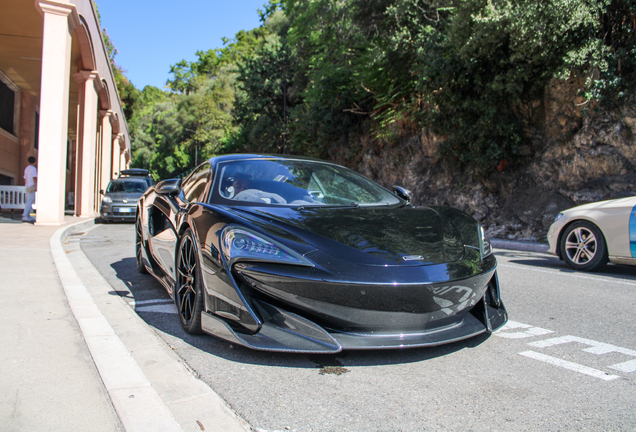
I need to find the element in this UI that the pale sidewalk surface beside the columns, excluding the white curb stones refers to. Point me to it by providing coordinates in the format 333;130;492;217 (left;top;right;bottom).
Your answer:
0;218;124;432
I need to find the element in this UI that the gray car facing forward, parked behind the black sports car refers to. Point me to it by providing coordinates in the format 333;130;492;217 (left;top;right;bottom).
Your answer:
99;177;148;222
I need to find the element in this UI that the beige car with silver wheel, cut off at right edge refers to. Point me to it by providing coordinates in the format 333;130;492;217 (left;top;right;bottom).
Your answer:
548;197;636;271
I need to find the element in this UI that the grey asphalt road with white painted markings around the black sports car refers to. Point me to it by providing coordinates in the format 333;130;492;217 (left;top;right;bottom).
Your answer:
81;224;636;432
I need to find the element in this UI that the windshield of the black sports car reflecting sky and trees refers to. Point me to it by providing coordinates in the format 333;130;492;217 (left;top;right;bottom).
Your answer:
214;159;400;206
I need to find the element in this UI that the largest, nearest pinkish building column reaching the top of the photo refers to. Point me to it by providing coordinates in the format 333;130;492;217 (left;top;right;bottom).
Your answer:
35;0;79;225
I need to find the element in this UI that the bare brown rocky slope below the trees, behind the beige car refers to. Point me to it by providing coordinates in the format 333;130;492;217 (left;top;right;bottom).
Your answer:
341;80;636;241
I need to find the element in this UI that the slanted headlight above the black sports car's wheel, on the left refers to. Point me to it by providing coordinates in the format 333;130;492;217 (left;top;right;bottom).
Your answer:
221;226;313;266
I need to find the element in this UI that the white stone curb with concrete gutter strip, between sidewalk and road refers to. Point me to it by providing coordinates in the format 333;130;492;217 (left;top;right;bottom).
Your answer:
50;219;252;432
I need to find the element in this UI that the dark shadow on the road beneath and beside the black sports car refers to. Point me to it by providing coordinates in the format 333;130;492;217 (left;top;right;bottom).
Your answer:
111;258;490;374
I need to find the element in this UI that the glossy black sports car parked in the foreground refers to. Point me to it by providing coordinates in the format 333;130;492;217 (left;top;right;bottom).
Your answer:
136;155;507;353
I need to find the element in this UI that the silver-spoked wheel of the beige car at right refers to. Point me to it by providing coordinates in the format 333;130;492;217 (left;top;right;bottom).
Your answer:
560;221;608;271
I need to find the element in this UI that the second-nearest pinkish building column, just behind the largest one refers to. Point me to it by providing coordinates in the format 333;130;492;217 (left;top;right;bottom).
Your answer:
73;71;100;217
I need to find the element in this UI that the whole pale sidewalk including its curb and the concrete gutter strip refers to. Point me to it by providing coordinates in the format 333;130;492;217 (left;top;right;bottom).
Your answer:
0;217;250;432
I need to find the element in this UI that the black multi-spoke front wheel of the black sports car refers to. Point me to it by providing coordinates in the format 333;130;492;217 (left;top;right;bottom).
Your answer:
174;229;203;334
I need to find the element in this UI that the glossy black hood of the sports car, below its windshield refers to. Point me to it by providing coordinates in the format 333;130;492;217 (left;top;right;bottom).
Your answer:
226;207;464;266
